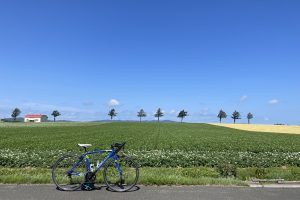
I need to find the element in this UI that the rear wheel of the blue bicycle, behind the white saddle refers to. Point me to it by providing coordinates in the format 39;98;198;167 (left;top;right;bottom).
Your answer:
52;154;86;191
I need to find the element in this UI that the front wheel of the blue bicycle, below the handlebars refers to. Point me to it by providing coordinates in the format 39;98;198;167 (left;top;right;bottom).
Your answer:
103;156;139;192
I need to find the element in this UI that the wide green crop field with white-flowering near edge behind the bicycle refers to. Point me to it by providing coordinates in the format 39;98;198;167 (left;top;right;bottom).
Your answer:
0;122;300;168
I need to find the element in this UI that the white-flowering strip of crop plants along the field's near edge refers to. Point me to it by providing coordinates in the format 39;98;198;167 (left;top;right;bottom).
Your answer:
0;149;300;168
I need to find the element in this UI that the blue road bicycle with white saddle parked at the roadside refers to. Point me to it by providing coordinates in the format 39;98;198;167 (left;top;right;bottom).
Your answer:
52;143;139;192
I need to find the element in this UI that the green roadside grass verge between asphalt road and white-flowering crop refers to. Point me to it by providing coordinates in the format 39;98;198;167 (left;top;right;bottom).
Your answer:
0;167;300;186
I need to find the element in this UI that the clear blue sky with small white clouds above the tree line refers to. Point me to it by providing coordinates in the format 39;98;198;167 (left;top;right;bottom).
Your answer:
0;0;300;124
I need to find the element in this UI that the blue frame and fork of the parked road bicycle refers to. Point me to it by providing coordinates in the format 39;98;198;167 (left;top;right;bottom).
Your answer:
69;148;122;176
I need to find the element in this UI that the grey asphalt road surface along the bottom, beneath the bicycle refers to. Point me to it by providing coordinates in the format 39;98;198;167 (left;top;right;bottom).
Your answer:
0;185;300;200
